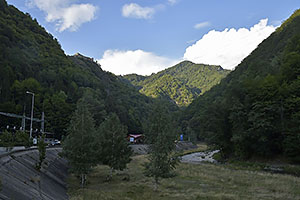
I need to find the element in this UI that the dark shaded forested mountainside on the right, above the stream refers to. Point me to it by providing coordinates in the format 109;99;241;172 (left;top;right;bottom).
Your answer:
182;10;300;162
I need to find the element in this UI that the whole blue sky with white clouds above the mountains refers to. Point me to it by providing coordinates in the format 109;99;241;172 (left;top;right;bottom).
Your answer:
7;0;300;75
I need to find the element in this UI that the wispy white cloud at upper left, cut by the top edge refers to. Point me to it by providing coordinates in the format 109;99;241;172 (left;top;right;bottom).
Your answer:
27;0;98;32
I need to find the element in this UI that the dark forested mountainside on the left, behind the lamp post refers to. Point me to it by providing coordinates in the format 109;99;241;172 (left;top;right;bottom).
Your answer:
0;0;164;137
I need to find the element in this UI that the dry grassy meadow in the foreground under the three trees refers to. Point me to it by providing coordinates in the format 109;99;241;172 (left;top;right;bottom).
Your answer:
69;145;300;200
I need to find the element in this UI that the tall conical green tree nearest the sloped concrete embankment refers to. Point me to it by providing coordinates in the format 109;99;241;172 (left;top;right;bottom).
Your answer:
63;100;97;187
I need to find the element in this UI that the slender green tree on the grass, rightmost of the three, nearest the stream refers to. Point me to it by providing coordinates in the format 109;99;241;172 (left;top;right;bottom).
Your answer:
145;104;178;190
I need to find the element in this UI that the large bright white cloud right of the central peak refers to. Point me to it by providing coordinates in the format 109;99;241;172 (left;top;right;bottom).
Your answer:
184;19;276;69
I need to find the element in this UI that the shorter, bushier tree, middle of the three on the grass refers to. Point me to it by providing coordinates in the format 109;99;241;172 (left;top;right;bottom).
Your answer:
97;113;132;178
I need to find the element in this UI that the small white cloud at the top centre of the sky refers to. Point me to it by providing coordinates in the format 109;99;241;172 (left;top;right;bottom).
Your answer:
122;3;155;19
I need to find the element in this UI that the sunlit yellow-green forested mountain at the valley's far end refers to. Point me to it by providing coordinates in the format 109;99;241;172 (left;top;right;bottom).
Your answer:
123;61;230;106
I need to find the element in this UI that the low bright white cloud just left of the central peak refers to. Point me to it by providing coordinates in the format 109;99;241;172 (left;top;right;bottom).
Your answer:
97;50;179;75
